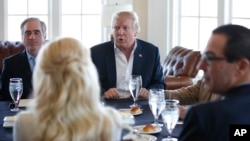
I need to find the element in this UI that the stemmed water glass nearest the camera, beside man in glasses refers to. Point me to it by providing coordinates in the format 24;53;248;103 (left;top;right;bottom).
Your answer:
161;99;179;141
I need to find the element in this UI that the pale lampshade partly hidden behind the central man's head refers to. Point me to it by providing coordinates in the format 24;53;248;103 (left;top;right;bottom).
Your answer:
101;3;133;42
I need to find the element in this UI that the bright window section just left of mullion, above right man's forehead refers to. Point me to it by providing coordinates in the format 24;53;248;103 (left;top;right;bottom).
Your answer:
179;0;217;50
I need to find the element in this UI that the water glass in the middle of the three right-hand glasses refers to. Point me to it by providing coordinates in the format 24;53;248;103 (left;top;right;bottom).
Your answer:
148;89;166;127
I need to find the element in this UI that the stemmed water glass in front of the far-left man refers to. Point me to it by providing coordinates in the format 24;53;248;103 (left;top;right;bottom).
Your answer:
9;78;23;112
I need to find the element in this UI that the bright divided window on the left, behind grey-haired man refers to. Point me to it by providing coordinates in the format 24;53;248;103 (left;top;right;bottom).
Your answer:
5;0;102;47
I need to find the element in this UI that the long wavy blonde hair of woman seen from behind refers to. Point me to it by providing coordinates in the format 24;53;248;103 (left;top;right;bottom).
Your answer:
30;38;119;141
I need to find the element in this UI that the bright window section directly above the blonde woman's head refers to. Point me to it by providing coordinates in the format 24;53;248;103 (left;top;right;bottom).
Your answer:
62;0;101;47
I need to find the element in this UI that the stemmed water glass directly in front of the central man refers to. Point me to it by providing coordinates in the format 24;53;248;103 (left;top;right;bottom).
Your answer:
129;75;142;107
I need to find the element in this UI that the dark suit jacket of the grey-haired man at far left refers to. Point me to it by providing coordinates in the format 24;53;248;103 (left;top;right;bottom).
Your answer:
1;50;33;100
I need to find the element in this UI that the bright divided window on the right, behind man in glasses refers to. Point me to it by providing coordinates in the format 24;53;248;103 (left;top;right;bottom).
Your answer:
173;0;250;51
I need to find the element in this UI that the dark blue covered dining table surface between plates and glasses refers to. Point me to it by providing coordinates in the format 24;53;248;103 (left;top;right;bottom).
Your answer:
0;98;182;141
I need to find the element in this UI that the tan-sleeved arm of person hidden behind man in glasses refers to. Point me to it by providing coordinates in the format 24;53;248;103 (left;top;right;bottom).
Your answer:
165;80;221;119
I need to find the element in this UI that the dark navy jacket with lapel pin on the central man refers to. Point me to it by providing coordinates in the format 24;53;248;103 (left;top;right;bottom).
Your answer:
91;39;165;94
